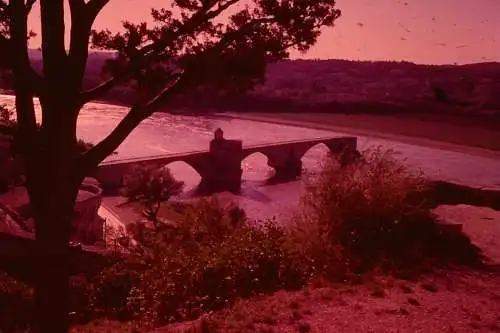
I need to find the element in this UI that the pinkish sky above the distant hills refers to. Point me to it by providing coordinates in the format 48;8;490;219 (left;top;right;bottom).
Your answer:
25;0;500;64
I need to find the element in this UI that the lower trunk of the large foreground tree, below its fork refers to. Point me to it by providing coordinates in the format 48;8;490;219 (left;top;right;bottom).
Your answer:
27;152;81;333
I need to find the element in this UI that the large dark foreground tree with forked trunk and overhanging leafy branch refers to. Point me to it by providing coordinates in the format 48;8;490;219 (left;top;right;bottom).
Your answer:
0;0;340;333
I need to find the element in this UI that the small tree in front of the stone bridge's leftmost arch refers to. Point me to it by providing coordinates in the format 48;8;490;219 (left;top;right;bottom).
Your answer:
122;166;184;227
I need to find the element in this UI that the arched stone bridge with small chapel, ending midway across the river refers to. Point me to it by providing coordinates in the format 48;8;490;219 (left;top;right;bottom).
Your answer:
94;131;357;193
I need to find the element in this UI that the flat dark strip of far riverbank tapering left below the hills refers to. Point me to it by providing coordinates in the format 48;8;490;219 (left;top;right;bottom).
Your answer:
225;113;500;156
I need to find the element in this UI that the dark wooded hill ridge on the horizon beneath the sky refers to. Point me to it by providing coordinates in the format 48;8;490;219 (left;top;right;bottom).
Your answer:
0;50;500;112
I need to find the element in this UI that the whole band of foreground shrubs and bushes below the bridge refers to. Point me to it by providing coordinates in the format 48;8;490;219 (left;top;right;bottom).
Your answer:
0;150;483;332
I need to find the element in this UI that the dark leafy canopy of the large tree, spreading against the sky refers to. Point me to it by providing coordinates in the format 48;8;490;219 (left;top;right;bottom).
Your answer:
92;0;340;92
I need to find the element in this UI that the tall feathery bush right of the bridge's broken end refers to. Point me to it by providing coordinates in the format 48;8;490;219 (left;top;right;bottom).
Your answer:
295;149;480;272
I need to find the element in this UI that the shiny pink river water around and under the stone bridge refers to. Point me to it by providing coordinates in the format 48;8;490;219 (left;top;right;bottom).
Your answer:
0;95;500;218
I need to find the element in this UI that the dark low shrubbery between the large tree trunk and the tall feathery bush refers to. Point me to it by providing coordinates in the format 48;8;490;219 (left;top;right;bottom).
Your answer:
38;198;300;327
